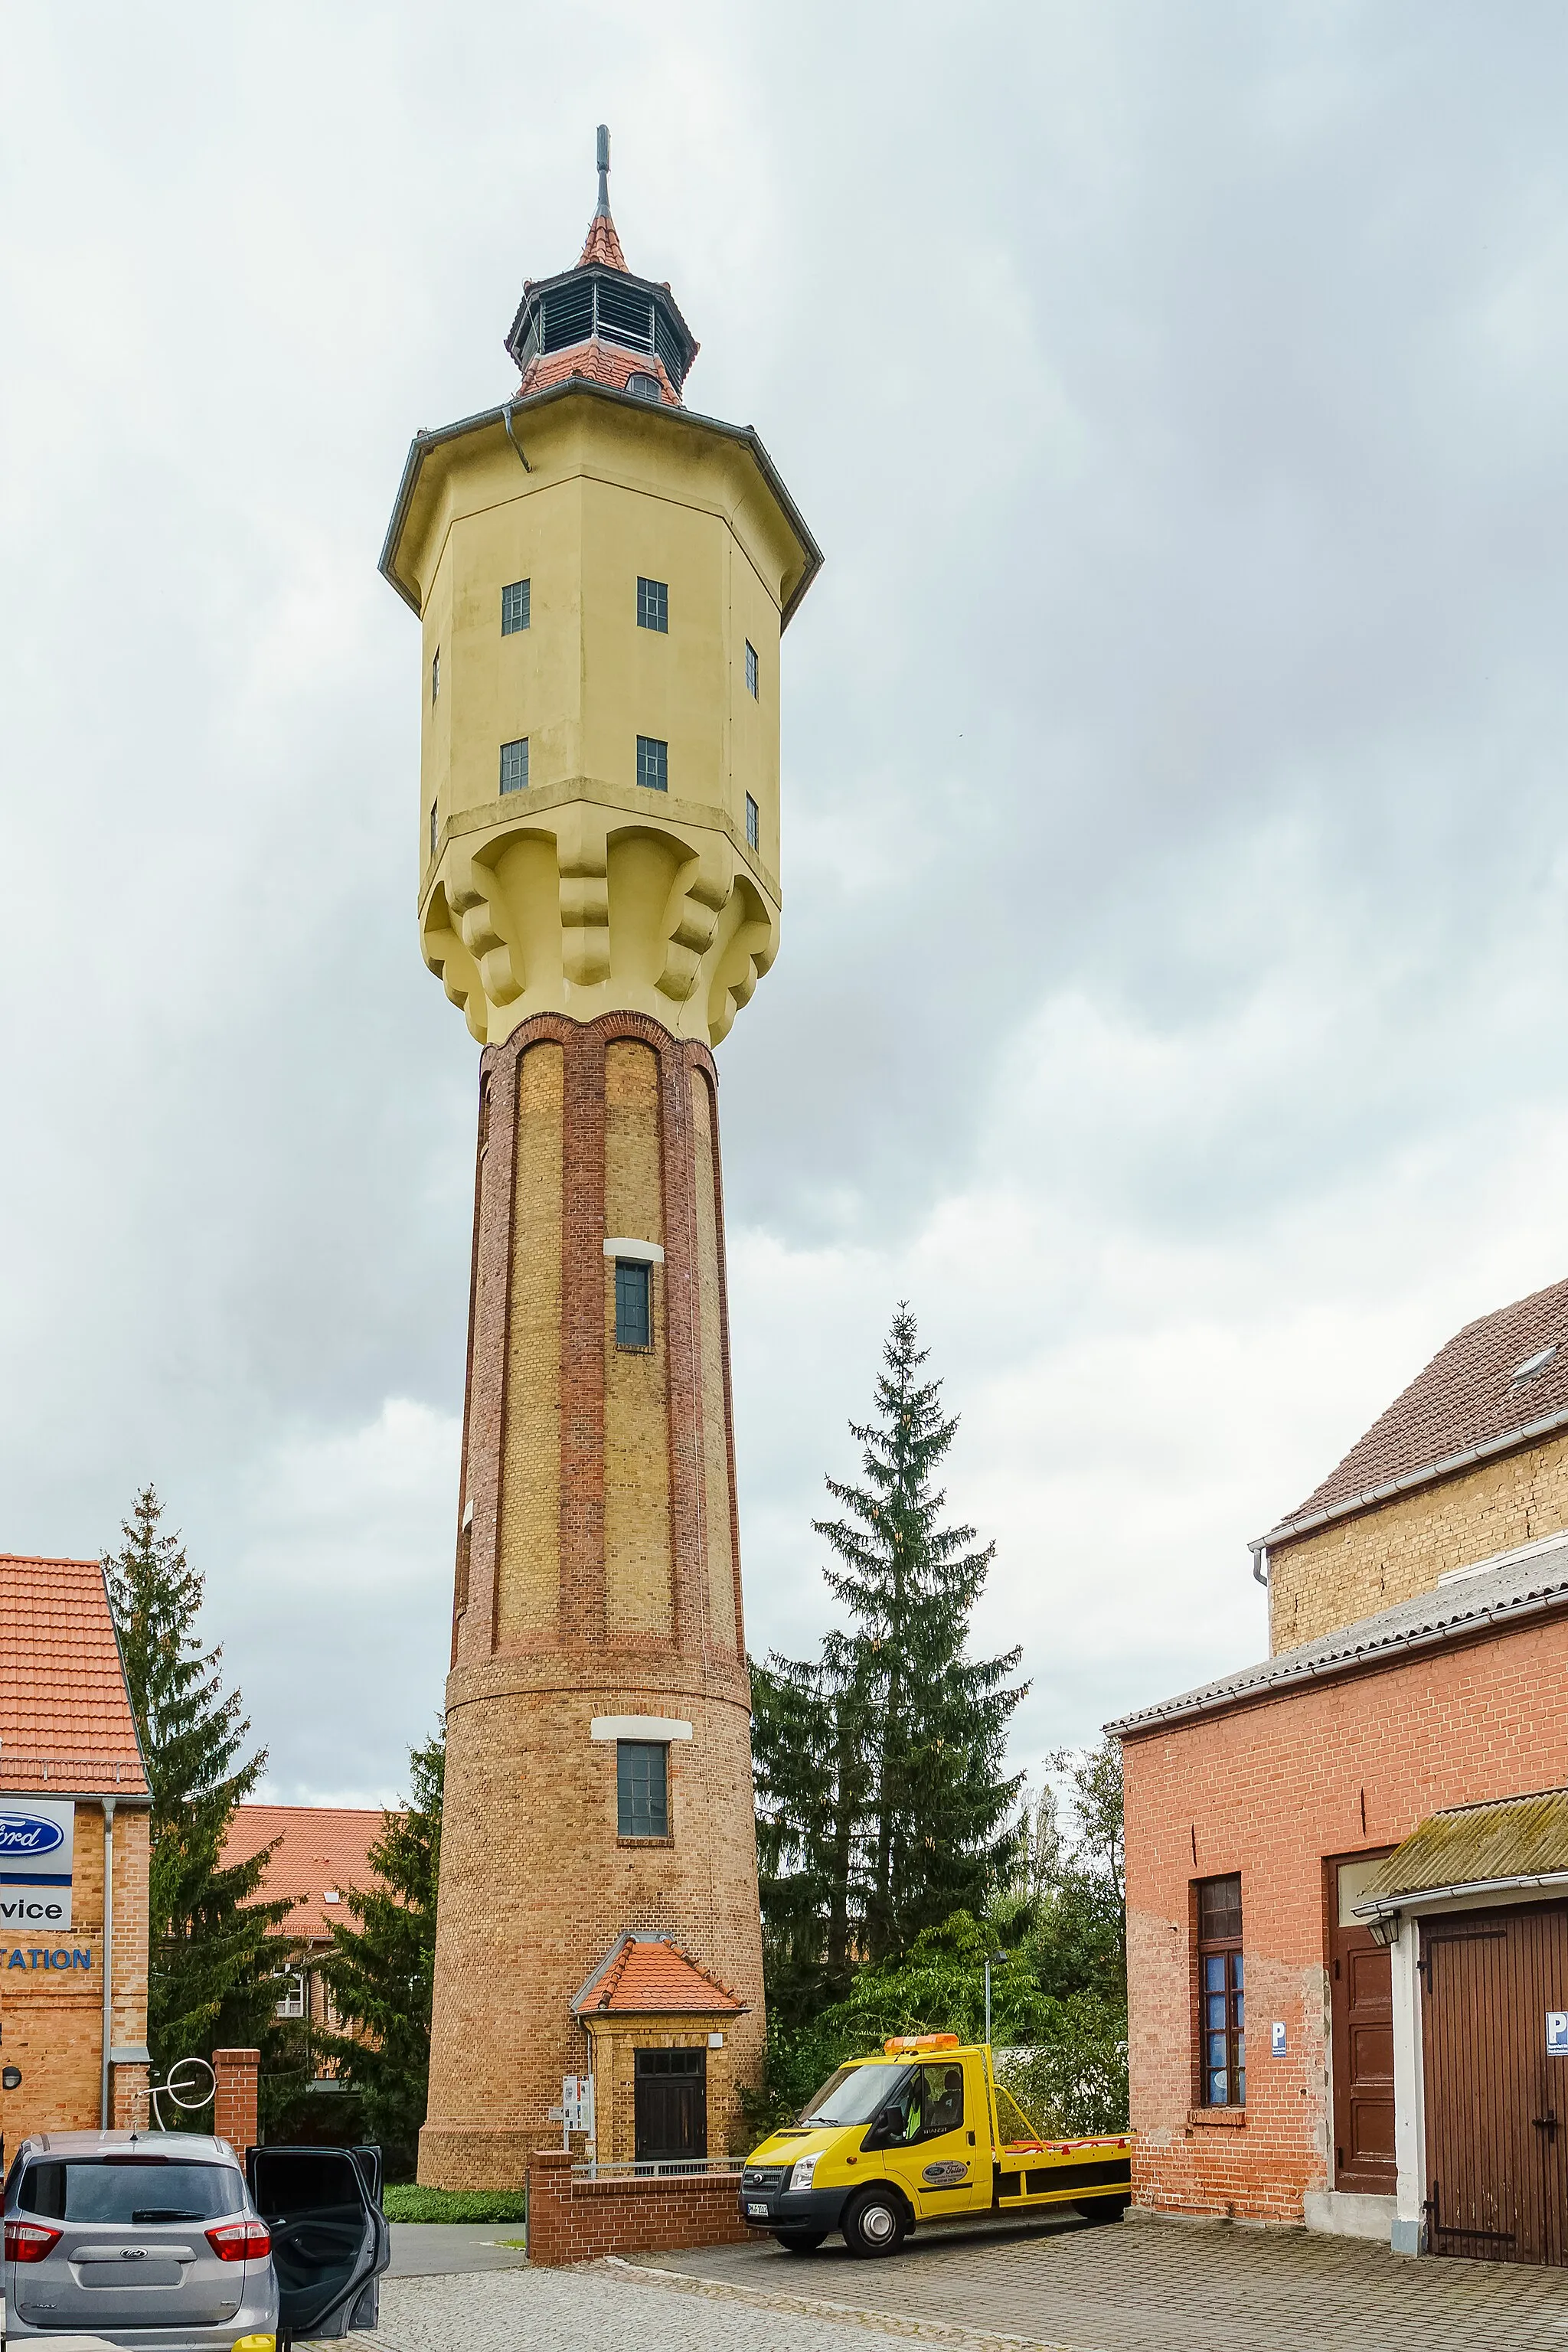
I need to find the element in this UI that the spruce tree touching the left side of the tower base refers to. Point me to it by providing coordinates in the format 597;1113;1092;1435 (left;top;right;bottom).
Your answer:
320;1729;446;2180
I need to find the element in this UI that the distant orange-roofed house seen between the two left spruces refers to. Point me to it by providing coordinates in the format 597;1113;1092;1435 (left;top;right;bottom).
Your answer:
224;1804;386;2086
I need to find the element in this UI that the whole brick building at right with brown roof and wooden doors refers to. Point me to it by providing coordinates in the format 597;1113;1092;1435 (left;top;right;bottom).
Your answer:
1109;1284;1568;2262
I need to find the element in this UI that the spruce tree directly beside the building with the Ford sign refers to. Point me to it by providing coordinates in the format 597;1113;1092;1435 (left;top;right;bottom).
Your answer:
103;1487;292;2072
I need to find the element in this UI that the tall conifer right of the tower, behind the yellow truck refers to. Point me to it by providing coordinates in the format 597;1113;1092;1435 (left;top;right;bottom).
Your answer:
757;1303;1025;1999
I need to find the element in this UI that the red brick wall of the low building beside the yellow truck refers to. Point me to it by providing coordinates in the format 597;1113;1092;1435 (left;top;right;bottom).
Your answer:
1124;1615;1568;2220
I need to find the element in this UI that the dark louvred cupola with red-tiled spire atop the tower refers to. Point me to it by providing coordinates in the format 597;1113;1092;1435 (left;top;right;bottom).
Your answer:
505;122;698;407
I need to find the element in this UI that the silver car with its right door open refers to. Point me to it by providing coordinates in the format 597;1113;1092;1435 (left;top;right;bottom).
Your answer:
5;2131;390;2352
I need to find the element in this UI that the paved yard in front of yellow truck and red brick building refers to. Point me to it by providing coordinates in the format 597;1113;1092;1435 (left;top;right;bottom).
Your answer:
625;2220;1568;2352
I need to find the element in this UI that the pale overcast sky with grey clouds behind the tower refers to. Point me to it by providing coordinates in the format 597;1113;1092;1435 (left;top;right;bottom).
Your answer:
0;0;1568;1802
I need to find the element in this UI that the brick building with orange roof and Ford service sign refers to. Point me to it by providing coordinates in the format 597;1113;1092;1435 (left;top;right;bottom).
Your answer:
0;1553;153;2148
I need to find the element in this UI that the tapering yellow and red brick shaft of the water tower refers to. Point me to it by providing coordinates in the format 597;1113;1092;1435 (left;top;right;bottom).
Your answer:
421;1011;764;2187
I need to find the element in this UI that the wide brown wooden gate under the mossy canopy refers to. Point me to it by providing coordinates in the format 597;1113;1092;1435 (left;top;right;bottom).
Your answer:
1420;1905;1568;2262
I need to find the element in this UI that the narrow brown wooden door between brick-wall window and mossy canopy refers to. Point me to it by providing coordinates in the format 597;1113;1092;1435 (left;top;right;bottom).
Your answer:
1328;1847;1396;2197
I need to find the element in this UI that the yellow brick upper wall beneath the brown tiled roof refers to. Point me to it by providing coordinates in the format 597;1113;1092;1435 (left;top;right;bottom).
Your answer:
1269;1435;1568;1651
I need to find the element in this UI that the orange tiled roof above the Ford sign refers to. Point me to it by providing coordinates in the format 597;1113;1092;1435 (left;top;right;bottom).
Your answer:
0;1553;148;1797
